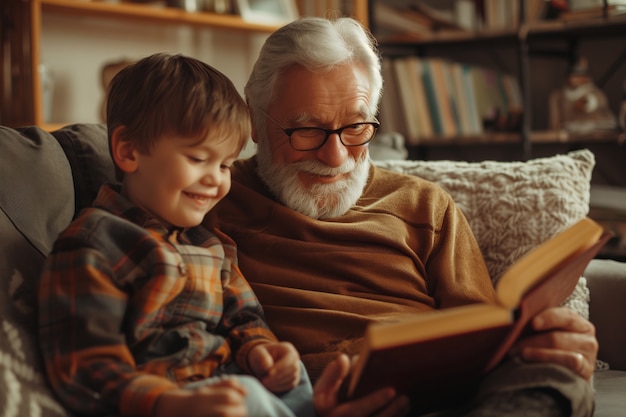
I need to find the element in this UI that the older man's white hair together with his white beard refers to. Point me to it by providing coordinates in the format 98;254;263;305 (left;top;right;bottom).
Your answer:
244;17;383;219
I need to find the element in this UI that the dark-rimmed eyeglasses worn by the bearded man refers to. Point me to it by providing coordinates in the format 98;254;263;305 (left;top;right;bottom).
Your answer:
259;109;380;151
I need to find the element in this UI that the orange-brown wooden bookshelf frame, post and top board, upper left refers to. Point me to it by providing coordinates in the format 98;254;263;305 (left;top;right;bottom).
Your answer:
2;0;276;130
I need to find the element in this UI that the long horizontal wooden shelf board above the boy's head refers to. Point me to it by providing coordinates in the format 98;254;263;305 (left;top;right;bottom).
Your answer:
39;0;278;33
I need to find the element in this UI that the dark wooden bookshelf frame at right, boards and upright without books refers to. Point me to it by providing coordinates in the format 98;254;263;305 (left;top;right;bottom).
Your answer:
370;0;626;159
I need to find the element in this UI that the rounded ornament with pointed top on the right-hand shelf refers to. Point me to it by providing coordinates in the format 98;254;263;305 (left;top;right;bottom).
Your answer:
550;57;617;134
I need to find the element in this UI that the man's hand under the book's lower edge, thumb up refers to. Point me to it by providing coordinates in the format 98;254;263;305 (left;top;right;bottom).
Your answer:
313;355;410;417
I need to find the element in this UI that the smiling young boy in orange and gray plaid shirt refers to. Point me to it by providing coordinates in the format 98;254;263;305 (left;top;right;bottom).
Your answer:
39;54;313;417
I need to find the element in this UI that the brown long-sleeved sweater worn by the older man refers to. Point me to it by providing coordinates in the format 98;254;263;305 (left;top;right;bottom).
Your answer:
205;158;494;380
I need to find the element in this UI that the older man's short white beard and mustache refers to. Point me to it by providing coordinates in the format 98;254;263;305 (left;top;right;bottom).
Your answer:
257;139;370;219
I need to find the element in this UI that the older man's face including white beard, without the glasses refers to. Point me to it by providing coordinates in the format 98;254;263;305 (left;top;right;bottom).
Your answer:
254;65;374;218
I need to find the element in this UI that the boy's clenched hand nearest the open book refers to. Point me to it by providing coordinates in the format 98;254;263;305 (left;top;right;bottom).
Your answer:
248;342;300;393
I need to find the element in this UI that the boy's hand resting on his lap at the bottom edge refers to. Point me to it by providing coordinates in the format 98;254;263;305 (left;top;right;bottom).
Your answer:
153;378;248;417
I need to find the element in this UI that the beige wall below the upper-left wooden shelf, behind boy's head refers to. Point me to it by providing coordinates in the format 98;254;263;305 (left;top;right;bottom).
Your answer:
41;13;267;123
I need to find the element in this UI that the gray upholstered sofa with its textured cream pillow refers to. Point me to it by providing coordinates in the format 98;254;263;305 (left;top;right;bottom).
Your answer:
0;124;626;417
